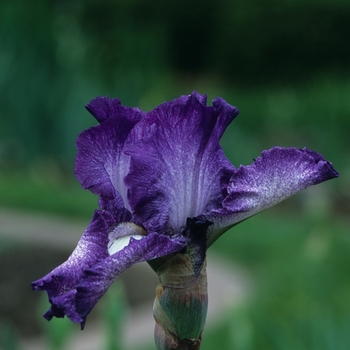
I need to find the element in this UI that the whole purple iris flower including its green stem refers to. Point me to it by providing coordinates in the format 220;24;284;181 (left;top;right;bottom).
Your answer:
32;92;338;349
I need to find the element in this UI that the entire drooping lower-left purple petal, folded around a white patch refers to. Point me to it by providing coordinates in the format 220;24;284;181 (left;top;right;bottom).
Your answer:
32;211;187;328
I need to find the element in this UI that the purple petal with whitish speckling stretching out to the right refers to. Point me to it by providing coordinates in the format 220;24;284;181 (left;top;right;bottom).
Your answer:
205;147;338;246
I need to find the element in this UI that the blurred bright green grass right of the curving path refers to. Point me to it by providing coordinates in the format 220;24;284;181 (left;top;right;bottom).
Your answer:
203;209;350;350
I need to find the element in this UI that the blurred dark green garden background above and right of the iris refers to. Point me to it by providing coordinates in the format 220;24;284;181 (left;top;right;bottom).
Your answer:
0;0;350;350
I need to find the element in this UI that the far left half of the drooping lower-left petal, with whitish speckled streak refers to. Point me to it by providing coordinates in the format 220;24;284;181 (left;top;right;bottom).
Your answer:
32;210;114;322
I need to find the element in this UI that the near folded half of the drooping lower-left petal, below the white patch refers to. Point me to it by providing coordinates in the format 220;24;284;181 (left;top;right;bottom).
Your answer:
72;233;186;326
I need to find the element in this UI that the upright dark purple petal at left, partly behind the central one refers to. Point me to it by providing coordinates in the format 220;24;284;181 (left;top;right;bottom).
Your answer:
75;97;143;221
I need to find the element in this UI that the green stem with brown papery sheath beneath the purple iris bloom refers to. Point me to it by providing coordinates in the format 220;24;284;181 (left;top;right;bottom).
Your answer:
153;254;208;350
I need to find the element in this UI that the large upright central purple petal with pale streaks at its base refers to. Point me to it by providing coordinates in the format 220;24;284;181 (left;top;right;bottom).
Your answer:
125;93;239;232
